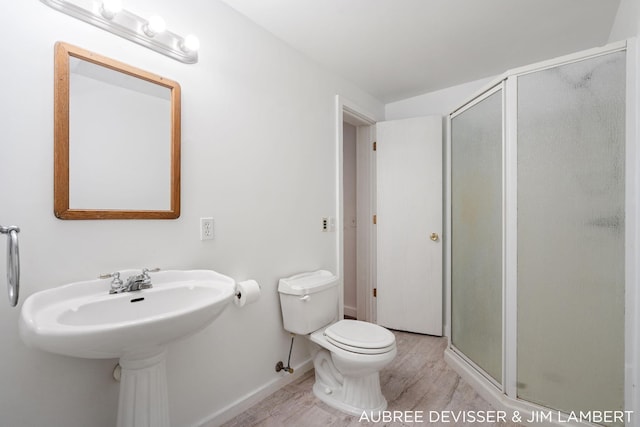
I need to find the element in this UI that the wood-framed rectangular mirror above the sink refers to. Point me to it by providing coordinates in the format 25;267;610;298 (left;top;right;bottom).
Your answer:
54;42;180;219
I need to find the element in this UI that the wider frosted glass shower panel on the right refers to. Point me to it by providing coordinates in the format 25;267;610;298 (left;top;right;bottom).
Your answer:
517;52;625;412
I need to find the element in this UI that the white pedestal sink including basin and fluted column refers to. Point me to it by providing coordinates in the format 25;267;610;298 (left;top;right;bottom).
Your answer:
20;270;235;427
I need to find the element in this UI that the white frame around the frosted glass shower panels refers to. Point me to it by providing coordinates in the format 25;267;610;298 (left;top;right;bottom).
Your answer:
444;38;640;427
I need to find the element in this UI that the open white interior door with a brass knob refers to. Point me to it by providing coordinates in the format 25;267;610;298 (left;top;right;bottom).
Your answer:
376;116;443;336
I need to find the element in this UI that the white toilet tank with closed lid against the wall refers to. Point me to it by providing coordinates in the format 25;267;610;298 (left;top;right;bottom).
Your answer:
278;270;338;335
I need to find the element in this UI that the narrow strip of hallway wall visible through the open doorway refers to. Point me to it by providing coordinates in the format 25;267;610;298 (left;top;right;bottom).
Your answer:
342;122;358;317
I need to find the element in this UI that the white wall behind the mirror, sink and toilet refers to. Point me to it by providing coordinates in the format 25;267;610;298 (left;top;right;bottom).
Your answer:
0;0;384;427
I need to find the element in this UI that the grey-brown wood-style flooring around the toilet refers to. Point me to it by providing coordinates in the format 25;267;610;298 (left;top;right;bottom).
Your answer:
223;331;518;427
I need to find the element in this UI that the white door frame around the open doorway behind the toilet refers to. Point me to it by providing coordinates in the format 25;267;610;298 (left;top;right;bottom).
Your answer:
335;94;377;323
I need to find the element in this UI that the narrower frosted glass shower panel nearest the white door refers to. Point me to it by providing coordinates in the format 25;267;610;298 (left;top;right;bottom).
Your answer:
451;86;503;384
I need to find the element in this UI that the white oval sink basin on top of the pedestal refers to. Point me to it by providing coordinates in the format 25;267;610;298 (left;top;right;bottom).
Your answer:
20;270;235;359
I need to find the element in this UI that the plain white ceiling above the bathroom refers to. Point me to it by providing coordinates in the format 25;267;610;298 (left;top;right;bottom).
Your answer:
222;0;620;103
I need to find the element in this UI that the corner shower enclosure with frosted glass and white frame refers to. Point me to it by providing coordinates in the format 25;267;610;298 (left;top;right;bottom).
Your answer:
446;38;637;425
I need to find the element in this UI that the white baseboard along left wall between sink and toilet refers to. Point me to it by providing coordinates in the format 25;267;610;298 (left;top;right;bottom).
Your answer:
194;359;313;427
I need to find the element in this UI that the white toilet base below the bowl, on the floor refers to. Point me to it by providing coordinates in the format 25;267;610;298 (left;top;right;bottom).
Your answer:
313;372;387;416
